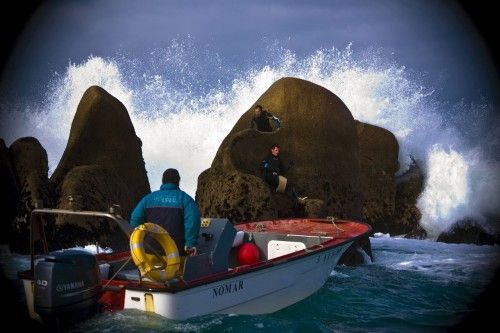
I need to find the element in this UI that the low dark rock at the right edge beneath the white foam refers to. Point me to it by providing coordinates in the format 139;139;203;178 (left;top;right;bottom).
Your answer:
437;219;500;245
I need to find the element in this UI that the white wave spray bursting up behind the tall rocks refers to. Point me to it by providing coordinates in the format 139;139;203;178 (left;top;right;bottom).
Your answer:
1;41;500;235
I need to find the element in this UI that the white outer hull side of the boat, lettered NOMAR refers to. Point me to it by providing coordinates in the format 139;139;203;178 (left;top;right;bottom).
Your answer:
124;242;352;320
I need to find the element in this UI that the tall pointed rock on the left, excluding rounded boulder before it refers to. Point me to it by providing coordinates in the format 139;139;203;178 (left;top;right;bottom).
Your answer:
50;86;150;206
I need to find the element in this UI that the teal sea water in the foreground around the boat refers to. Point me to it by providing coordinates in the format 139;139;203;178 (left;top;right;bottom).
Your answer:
0;237;488;332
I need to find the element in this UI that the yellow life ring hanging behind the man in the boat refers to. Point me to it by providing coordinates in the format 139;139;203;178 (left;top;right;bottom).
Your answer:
130;223;181;282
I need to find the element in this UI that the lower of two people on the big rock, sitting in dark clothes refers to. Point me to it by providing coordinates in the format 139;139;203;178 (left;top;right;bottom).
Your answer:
261;144;307;201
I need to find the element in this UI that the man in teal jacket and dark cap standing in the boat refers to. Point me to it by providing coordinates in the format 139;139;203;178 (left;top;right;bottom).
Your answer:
130;169;201;255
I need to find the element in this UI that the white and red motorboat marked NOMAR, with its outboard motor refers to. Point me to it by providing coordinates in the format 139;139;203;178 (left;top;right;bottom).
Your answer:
19;209;371;321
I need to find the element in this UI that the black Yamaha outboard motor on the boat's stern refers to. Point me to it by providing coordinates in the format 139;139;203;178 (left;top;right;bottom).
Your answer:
34;250;101;322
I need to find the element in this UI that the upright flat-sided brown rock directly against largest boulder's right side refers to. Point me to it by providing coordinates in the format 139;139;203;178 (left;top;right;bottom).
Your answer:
356;122;399;233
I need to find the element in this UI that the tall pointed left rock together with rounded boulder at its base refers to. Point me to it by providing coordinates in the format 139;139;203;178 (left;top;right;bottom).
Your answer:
50;86;150;248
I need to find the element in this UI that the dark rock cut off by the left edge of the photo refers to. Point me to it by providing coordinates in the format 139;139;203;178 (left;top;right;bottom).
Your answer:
0;139;19;244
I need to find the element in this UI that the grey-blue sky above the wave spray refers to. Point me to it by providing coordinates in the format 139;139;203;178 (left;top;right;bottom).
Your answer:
0;0;498;102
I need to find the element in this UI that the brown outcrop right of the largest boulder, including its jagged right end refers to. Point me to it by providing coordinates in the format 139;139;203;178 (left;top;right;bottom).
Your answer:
357;122;427;239
